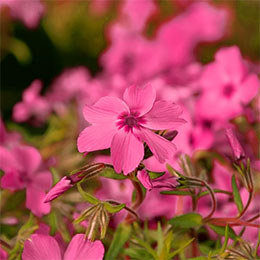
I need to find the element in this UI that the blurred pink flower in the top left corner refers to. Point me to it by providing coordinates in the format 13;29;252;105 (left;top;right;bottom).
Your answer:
0;0;45;29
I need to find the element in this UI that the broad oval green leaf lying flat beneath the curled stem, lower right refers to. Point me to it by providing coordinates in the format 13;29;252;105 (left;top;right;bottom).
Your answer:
169;213;202;228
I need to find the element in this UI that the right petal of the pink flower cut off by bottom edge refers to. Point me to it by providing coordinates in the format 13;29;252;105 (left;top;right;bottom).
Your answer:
63;234;105;260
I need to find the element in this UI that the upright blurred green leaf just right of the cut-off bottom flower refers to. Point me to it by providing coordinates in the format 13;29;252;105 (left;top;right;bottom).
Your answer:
105;224;131;260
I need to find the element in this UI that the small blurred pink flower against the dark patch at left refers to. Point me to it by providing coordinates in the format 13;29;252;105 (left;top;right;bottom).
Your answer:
13;79;51;123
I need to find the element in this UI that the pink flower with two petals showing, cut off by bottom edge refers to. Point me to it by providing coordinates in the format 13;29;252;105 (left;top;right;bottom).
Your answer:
22;234;104;260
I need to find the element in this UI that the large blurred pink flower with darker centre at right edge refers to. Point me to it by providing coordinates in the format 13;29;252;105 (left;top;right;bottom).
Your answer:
198;46;259;120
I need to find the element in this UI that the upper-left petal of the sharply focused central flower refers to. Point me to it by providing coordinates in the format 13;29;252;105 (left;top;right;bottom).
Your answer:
83;97;129;125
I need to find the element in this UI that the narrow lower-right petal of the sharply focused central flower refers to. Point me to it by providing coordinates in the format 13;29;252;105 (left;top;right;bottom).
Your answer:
136;128;176;163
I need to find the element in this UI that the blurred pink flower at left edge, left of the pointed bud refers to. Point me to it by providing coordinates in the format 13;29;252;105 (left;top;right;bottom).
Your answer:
0;146;52;217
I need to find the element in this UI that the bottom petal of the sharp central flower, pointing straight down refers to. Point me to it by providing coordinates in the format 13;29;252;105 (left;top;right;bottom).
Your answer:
111;129;144;175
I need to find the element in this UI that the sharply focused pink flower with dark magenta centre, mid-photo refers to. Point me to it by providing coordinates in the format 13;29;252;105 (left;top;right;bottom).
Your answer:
77;85;185;175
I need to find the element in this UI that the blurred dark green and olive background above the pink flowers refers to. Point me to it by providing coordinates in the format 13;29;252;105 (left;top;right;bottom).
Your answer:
0;0;260;121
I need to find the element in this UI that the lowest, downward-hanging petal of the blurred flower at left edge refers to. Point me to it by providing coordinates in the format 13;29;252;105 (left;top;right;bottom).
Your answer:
26;186;51;217
